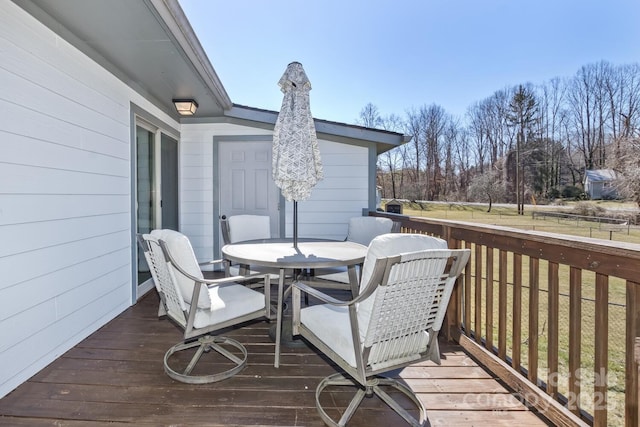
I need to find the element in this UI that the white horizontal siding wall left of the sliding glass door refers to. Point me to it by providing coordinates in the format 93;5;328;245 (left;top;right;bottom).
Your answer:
0;1;177;397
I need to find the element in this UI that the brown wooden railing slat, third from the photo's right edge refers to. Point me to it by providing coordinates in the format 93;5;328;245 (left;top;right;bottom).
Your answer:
567;267;582;415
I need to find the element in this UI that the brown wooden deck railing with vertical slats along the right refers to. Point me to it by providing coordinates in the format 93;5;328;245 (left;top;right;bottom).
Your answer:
370;212;640;426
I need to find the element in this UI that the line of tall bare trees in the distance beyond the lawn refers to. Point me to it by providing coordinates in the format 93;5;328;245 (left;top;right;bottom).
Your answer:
358;61;640;213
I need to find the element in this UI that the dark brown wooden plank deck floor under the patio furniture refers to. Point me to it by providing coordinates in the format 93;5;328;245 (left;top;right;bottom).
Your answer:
0;292;549;427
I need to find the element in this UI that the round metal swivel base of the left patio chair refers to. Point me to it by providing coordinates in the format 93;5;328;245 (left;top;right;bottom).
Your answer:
164;335;247;384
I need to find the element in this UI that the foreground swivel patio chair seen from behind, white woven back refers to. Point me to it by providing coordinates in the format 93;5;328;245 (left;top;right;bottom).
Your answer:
293;233;470;426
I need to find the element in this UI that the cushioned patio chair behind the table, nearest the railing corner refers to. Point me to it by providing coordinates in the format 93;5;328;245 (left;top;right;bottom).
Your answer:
313;216;400;289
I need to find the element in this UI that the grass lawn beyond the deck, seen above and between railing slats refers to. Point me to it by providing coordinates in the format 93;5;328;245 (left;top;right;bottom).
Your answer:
390;202;640;425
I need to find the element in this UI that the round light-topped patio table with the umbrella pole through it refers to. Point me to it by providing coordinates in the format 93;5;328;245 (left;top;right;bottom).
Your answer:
222;239;367;368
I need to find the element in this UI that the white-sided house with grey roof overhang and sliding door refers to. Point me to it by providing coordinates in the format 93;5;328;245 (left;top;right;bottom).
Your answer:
0;0;405;398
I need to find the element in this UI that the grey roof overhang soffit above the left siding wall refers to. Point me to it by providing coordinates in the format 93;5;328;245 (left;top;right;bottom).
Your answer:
13;0;232;120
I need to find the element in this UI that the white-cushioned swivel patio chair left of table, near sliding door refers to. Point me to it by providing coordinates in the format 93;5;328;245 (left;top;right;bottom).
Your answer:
138;230;271;384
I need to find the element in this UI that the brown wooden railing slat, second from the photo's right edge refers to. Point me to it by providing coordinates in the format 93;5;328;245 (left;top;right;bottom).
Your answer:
593;274;609;427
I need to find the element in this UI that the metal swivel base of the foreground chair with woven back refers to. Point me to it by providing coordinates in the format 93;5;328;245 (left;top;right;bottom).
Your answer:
316;373;427;427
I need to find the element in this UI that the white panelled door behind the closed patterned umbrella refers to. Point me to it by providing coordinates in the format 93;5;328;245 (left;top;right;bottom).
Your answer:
218;138;280;237
